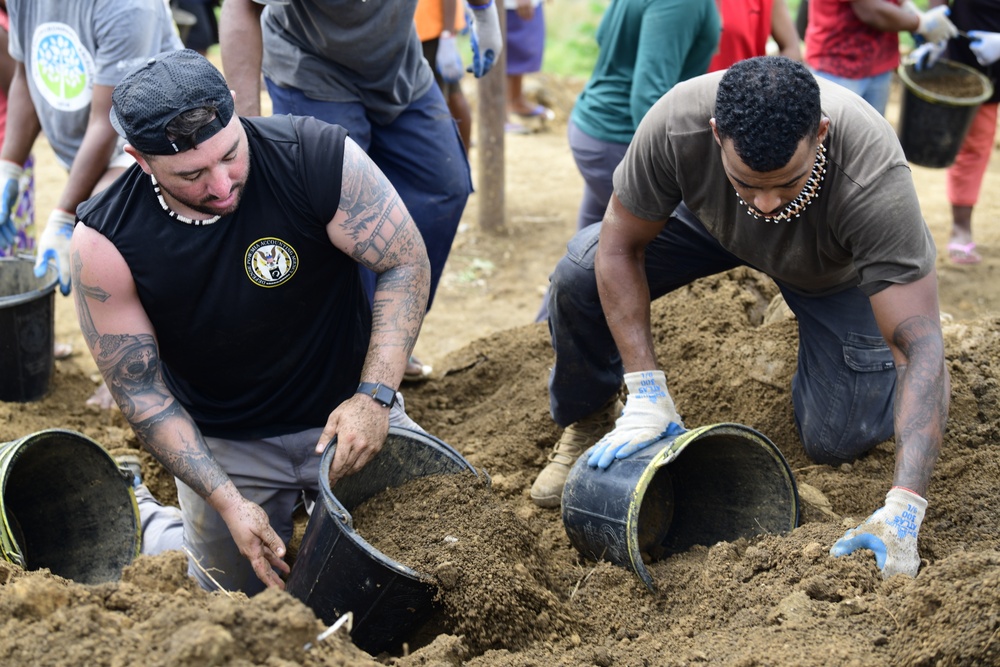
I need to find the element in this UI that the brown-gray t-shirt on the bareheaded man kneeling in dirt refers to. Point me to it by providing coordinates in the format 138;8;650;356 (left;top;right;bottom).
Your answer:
614;72;936;296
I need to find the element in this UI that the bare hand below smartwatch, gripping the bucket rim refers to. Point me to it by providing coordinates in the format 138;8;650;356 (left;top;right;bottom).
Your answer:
316;394;389;486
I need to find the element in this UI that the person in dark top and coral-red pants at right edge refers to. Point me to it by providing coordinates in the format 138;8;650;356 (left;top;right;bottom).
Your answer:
910;0;1000;264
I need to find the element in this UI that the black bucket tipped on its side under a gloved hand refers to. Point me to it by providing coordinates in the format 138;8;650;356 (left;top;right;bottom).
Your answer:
562;423;799;590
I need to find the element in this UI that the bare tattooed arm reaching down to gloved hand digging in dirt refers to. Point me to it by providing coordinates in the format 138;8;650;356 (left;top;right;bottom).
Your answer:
871;271;951;496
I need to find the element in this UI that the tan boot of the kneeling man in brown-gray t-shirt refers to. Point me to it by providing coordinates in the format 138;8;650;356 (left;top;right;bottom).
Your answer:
531;396;625;507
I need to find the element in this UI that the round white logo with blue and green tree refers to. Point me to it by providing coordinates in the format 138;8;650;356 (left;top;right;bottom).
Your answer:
30;23;94;111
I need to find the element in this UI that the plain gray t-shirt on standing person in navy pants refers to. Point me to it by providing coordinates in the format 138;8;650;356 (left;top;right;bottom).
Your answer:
256;0;434;125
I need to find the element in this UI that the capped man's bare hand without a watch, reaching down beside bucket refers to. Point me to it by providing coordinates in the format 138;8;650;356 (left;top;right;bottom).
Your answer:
220;486;290;590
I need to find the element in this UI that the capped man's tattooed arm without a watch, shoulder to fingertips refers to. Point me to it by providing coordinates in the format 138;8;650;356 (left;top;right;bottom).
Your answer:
70;225;289;588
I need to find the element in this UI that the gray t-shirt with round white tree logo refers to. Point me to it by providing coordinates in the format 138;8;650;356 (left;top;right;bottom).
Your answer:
7;0;183;169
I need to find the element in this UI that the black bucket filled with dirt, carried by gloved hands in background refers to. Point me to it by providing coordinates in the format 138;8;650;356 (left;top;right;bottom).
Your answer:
897;58;993;168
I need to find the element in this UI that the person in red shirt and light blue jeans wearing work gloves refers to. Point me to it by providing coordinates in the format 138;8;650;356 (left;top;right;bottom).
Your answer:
805;0;958;115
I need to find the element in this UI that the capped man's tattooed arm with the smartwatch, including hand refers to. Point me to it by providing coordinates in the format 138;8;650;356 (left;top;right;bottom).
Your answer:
316;139;430;482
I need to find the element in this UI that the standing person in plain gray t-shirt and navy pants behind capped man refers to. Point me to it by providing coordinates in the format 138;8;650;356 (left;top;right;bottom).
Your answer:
219;0;503;380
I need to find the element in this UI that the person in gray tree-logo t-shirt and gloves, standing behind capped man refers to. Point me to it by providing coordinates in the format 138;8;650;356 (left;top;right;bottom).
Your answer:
0;0;182;407
